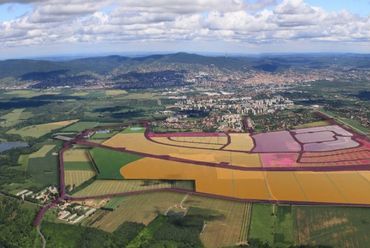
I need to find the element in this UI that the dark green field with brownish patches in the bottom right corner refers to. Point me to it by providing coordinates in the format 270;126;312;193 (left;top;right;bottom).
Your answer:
294;206;370;248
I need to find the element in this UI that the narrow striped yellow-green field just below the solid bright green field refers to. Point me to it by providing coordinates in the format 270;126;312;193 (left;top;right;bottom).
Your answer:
73;180;171;196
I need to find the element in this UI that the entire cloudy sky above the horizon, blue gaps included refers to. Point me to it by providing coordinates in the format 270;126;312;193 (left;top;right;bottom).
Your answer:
0;0;370;59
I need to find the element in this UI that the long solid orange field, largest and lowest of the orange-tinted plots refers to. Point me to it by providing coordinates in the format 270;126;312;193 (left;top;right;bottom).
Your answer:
121;158;370;204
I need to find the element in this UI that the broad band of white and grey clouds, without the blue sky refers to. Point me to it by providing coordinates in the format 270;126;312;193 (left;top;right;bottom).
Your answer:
0;0;370;51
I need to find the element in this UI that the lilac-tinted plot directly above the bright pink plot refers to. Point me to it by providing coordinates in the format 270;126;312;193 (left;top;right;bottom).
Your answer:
253;131;301;152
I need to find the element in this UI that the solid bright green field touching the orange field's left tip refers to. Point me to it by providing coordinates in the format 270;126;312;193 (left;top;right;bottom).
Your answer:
90;148;141;179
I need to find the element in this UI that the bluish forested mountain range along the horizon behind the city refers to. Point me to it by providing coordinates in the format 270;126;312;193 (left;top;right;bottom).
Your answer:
0;53;370;88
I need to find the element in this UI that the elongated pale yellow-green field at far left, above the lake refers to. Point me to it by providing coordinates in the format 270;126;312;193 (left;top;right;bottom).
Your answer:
7;120;78;138
